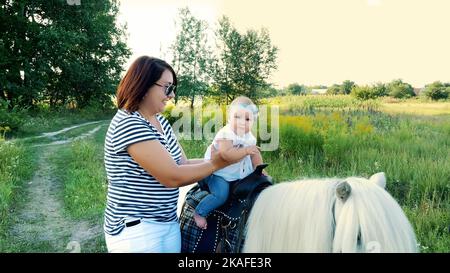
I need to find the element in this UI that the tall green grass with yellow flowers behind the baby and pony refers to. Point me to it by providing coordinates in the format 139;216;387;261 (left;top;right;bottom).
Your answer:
181;109;450;252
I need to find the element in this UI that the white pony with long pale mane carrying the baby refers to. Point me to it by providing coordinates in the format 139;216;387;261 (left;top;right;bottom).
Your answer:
243;173;417;252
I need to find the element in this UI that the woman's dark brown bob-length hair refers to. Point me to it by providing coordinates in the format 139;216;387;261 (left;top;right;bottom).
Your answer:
116;56;177;112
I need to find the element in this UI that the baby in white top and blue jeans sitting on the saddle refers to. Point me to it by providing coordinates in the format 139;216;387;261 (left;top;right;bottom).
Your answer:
194;96;263;229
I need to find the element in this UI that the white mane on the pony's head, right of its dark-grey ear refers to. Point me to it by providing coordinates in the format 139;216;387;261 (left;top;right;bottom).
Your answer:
333;177;417;252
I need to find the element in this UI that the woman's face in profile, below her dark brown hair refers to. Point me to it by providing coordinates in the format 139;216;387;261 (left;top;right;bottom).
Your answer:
140;69;175;114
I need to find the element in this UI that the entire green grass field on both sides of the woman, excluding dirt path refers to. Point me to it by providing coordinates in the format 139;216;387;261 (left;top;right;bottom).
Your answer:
0;96;450;253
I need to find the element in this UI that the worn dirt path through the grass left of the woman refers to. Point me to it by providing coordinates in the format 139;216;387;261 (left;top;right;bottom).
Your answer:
10;121;102;252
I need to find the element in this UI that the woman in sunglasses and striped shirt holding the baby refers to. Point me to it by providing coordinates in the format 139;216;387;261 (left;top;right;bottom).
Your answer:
104;56;243;252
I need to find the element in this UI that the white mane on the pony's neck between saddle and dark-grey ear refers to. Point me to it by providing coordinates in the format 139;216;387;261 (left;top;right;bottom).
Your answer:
243;179;338;252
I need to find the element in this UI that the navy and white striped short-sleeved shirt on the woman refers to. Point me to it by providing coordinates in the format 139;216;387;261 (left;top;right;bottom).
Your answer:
104;110;182;235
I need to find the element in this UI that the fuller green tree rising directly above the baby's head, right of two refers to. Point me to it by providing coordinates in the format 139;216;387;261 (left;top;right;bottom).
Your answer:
211;16;278;104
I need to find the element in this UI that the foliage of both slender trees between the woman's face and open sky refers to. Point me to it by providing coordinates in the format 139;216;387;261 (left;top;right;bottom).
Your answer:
171;8;278;103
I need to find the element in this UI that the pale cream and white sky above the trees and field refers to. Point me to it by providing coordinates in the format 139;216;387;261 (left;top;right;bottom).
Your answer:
119;0;450;87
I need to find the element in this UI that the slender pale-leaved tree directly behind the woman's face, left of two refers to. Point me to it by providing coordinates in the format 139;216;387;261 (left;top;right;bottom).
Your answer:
171;8;212;109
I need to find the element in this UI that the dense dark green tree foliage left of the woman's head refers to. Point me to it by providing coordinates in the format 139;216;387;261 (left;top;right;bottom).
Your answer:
0;0;130;108
